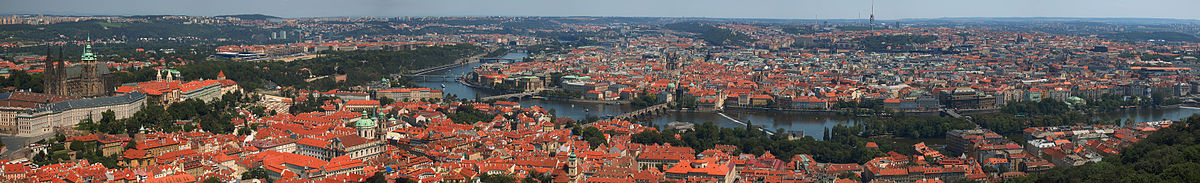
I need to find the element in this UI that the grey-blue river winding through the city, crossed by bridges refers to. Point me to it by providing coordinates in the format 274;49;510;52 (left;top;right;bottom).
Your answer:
416;53;1200;138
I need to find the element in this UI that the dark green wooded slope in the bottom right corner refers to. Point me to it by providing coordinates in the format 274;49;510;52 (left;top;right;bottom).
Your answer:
1013;116;1200;183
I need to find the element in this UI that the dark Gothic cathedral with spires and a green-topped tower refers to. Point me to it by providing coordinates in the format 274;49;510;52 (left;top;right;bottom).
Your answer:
42;43;118;98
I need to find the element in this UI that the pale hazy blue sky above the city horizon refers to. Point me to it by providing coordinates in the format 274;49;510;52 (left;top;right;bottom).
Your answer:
0;0;1200;19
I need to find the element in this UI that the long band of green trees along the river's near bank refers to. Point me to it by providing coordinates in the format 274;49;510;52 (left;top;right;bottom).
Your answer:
631;113;974;164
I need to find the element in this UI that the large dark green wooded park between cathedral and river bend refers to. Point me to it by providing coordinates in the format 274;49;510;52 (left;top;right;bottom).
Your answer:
178;45;484;90
